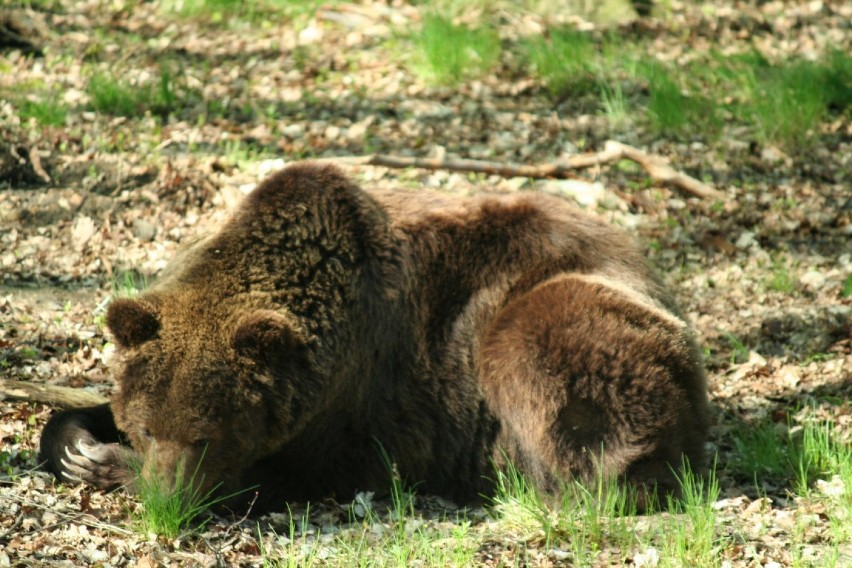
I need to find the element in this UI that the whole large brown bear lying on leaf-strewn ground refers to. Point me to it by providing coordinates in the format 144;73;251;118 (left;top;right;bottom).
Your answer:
41;163;708;510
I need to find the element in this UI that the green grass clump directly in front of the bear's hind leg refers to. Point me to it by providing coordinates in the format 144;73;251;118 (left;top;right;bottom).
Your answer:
493;450;724;566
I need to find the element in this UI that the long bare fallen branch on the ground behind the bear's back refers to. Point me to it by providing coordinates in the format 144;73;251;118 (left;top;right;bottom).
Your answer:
321;140;725;199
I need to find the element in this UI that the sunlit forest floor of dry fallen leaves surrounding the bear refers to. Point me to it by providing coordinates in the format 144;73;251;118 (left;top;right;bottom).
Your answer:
0;0;852;567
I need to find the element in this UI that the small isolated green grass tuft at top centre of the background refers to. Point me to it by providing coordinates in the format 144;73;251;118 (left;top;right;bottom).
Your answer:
415;14;500;85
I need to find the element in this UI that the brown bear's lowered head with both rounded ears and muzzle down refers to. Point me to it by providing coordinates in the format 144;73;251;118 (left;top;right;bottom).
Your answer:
106;293;322;504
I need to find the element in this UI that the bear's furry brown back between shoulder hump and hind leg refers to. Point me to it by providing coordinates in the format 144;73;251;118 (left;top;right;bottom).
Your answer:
362;190;673;353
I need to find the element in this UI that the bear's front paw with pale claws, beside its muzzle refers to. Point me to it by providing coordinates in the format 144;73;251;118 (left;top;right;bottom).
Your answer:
59;440;136;489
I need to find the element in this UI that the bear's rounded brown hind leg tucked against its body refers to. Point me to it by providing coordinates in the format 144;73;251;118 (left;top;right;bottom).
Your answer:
479;275;707;506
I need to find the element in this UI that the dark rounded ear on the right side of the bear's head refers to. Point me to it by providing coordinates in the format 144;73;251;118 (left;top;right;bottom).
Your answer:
231;310;304;362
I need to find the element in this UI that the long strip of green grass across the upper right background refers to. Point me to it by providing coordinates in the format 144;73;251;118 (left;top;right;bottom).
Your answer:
521;42;852;146
